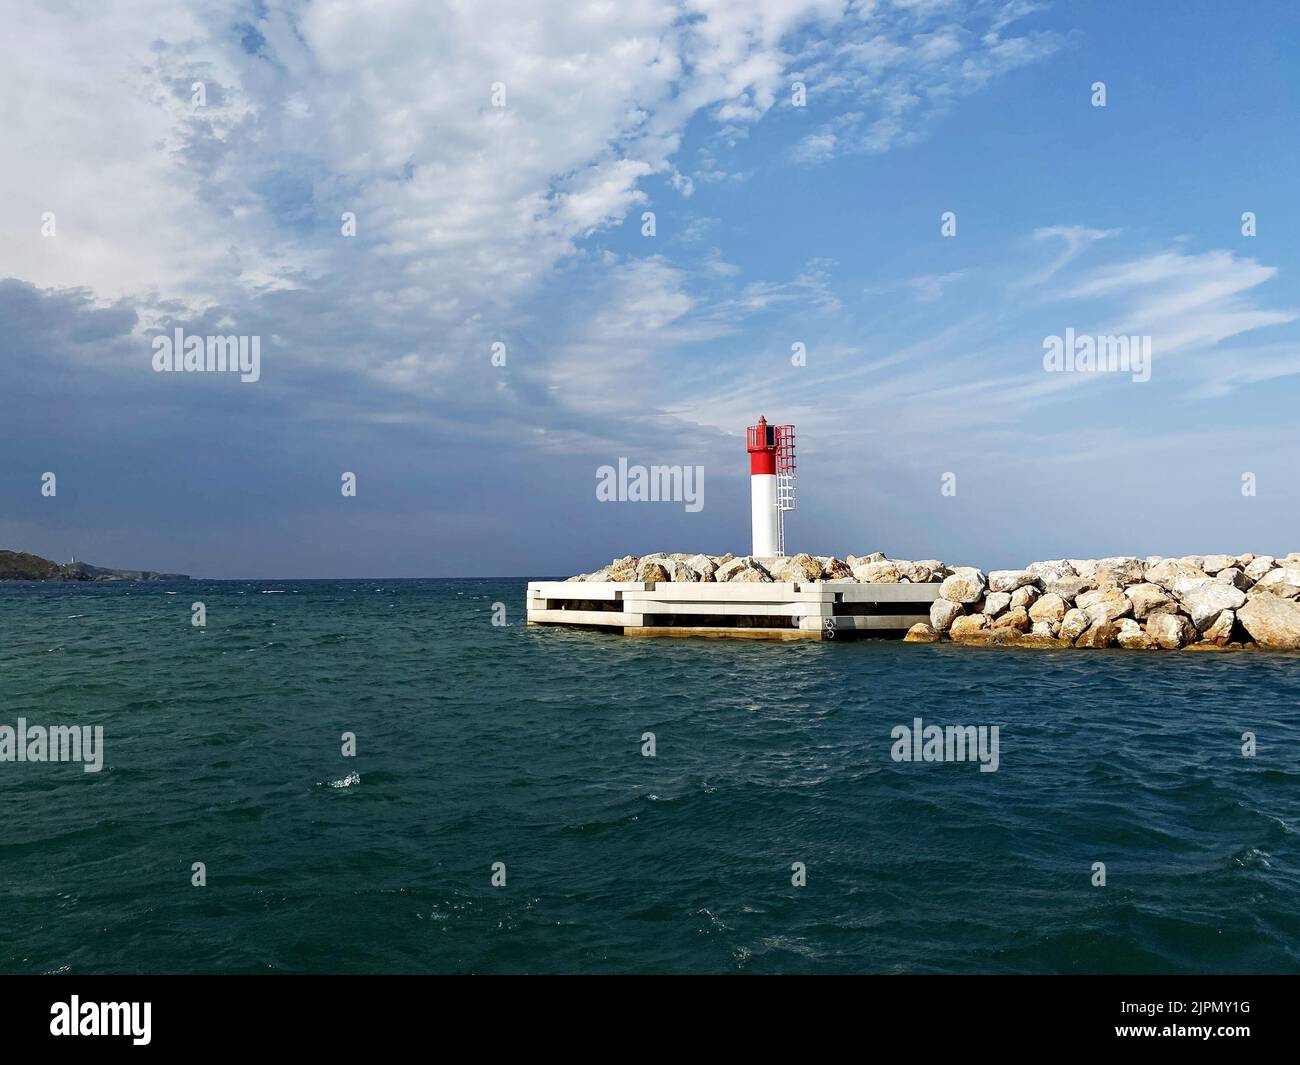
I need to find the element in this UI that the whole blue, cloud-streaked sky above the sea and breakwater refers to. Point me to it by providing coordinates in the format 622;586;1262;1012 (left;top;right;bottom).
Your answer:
0;0;1300;579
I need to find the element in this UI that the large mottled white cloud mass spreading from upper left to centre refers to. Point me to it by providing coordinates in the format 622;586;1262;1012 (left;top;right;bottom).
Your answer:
0;0;1076;465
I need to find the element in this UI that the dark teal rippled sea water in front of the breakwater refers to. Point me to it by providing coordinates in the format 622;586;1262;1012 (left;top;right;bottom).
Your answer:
0;580;1300;973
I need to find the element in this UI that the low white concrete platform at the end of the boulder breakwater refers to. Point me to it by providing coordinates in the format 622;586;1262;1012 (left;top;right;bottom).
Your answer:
527;581;939;640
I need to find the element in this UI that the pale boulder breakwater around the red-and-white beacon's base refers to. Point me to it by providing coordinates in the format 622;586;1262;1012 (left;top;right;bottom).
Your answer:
569;551;1300;650
